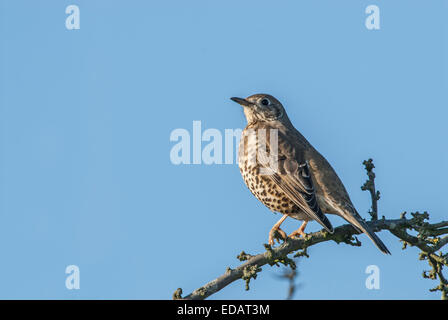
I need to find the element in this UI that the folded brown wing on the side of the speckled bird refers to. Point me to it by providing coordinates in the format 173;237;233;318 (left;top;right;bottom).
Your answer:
257;141;333;232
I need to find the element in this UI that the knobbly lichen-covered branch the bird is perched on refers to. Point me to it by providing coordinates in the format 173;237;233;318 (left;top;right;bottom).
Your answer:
173;159;448;300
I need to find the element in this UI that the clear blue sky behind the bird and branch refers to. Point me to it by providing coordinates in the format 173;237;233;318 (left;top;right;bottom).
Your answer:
0;0;448;299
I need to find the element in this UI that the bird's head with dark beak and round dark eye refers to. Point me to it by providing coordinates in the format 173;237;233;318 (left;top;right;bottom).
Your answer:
230;94;287;123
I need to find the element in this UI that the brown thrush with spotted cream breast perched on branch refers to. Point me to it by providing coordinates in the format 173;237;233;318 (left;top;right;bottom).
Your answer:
230;94;390;254
